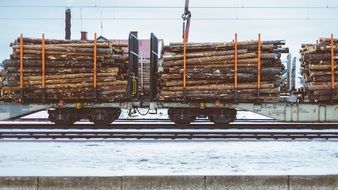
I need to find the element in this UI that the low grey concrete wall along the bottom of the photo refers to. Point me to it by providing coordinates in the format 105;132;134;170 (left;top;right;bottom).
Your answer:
0;175;338;190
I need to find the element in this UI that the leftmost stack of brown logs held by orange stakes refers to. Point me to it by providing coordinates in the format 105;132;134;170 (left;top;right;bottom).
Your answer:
2;38;128;102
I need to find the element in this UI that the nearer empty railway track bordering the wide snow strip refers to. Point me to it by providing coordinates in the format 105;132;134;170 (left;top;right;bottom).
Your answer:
0;130;338;140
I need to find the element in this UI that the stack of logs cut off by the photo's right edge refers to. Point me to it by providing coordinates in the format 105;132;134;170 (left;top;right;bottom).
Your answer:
300;38;338;102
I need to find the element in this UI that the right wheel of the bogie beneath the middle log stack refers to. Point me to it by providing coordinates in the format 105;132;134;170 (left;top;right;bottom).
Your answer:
209;108;237;127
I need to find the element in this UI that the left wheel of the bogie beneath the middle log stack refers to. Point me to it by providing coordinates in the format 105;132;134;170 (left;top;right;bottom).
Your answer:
168;108;196;126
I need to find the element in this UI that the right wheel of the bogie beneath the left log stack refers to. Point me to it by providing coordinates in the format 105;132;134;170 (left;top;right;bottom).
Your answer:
89;108;121;127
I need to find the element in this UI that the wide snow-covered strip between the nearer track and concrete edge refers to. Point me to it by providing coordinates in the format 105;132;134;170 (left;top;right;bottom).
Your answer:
0;141;338;176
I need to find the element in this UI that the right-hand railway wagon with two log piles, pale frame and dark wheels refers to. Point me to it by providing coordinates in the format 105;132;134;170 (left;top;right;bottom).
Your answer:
151;34;338;126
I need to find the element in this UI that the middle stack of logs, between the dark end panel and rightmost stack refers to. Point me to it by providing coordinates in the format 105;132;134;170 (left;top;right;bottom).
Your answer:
158;40;289;102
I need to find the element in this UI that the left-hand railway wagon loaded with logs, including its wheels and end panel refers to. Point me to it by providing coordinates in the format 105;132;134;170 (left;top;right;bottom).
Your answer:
1;32;138;125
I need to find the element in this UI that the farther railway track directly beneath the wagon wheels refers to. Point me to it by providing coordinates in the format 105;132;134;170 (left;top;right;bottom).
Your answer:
0;120;338;129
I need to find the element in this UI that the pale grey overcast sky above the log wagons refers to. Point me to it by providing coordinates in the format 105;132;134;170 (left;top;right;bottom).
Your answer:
0;0;338;60
